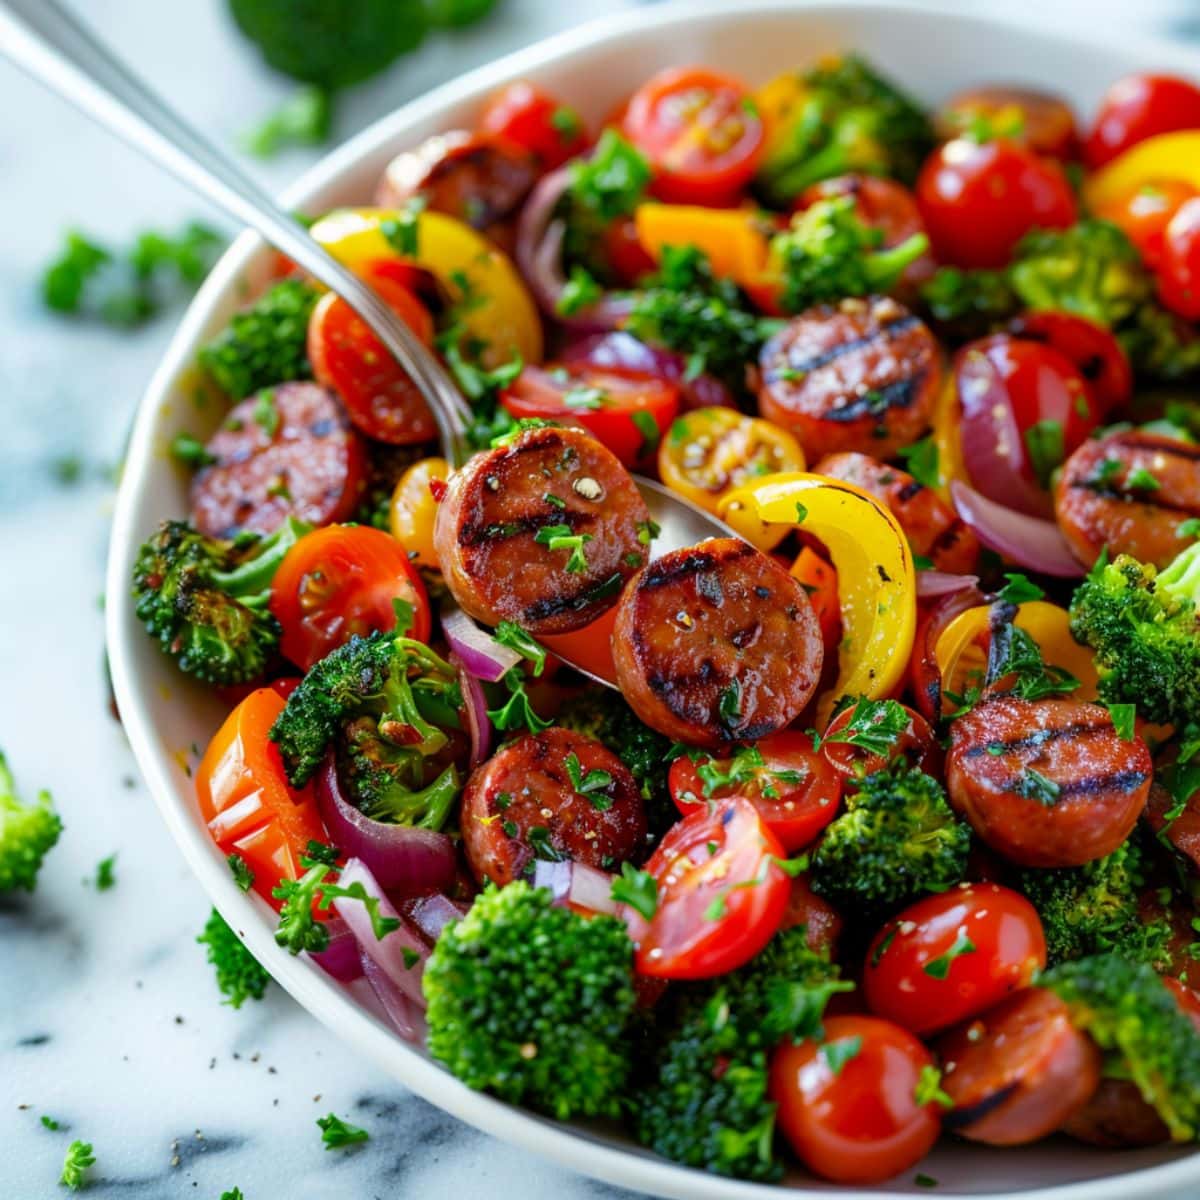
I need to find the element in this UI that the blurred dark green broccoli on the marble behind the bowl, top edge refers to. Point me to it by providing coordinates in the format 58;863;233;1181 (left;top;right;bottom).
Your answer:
229;0;497;157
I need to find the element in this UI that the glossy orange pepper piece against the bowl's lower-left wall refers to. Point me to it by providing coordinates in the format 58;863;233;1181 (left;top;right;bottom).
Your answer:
196;688;328;908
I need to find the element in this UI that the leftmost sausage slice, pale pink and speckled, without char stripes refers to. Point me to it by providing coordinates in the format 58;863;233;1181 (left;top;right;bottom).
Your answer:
191;383;367;538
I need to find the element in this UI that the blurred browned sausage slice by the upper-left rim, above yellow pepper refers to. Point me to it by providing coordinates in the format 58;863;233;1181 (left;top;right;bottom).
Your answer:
378;130;538;248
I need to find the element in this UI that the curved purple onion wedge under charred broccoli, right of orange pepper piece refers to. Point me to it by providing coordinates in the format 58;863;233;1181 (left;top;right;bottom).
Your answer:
316;751;457;895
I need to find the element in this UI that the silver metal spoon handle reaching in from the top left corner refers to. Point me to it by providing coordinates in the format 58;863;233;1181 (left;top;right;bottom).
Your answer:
0;0;470;463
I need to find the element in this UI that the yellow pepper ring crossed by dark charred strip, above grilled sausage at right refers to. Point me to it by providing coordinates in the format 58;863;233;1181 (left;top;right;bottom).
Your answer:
934;600;1100;712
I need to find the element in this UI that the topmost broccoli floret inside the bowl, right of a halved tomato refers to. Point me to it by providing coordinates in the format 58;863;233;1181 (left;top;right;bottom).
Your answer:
757;54;934;206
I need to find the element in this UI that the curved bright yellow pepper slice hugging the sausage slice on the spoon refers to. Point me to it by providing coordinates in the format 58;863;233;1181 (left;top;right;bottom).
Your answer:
725;472;917;728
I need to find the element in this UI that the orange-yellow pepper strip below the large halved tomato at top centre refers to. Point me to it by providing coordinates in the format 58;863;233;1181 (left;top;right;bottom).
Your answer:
634;204;772;286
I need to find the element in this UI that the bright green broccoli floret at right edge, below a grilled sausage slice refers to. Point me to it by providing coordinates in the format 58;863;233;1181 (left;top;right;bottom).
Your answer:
1070;542;1200;726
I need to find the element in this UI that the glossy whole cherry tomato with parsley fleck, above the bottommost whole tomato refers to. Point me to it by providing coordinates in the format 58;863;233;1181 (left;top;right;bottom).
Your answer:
863;883;1046;1034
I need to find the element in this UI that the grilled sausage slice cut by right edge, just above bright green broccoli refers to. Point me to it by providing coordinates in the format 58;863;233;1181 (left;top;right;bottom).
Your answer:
1055;430;1200;568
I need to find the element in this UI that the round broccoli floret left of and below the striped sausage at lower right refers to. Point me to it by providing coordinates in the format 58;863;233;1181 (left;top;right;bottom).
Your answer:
812;758;971;913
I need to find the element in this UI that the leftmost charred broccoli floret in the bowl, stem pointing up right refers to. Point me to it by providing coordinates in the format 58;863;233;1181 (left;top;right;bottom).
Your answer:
133;517;308;684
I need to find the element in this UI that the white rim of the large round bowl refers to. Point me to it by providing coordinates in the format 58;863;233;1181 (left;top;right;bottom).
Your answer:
104;0;1200;1200
